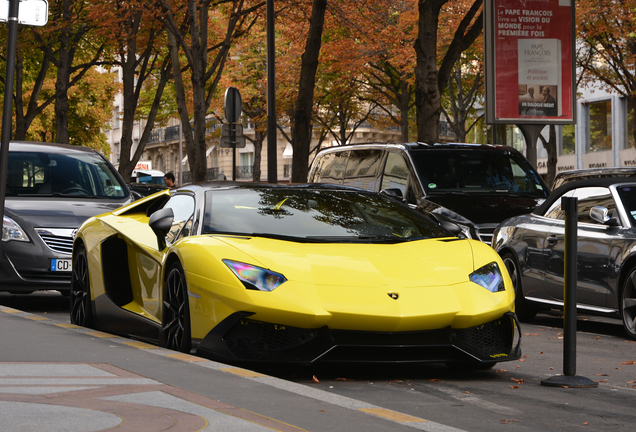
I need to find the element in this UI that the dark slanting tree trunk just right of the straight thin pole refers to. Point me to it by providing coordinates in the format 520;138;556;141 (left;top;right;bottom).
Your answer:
292;0;327;182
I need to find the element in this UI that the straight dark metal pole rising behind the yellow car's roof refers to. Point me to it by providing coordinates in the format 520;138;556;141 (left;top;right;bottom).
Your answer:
267;0;278;183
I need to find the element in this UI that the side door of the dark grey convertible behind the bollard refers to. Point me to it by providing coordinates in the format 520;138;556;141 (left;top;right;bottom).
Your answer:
543;186;618;307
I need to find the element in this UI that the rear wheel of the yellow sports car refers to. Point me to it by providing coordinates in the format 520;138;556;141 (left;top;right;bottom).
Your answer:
69;244;95;328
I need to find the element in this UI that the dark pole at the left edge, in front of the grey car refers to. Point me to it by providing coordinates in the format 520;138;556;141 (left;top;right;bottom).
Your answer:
0;0;20;252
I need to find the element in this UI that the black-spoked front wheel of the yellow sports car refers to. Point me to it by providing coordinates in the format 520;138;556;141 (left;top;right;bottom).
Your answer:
161;261;192;353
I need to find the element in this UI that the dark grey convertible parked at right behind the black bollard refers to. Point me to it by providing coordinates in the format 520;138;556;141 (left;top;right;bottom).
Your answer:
493;178;636;339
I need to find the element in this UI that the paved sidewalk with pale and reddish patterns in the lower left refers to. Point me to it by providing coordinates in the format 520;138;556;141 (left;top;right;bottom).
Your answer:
0;306;468;432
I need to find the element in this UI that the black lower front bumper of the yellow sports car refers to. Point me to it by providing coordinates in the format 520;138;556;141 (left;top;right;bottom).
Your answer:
197;312;521;365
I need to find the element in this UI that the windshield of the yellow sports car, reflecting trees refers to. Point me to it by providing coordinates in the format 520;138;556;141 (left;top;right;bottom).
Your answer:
204;188;451;242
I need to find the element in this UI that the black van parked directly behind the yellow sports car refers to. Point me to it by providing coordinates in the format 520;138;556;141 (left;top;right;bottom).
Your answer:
309;143;549;244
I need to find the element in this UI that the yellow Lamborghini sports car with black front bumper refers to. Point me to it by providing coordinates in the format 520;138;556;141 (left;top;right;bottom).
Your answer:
70;182;521;367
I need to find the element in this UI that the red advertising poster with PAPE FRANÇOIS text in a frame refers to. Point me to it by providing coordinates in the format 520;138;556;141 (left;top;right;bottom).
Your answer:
486;0;576;124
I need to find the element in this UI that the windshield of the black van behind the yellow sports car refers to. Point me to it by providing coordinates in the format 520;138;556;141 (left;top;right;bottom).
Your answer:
411;149;548;198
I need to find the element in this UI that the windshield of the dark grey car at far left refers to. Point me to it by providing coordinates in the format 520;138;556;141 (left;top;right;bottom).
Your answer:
6;151;128;198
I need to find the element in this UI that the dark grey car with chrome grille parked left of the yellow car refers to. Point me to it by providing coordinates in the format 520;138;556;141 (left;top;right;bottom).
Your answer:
0;142;132;294
